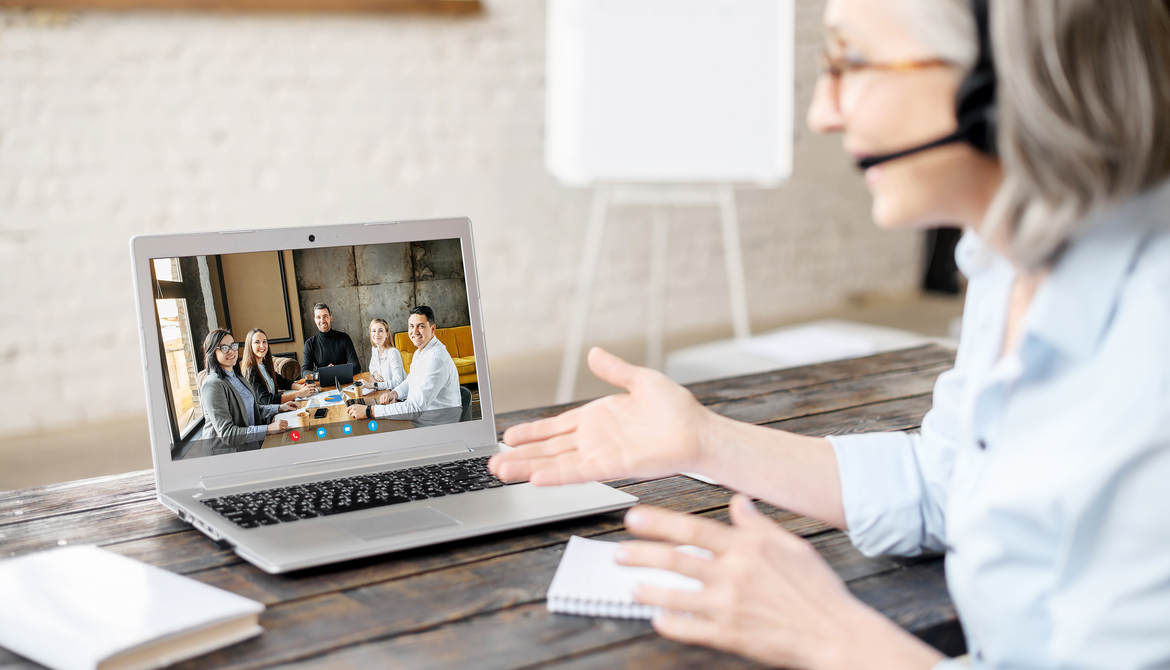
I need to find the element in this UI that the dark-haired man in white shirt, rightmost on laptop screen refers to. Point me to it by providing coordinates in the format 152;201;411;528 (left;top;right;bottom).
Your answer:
349;305;462;426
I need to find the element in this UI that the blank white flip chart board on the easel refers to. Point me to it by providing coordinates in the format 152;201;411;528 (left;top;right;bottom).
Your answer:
545;0;794;186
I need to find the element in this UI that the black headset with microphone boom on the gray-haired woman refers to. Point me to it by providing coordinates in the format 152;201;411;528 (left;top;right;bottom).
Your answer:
858;0;997;170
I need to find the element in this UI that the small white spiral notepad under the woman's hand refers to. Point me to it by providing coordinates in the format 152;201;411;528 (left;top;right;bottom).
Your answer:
548;536;711;619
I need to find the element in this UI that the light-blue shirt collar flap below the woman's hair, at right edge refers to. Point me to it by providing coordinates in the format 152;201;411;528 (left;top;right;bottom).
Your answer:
1024;182;1170;359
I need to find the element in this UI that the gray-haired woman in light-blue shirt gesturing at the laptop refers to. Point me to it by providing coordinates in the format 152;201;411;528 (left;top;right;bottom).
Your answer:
491;0;1170;669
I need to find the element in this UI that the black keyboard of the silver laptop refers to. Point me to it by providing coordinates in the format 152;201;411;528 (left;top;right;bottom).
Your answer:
200;456;504;529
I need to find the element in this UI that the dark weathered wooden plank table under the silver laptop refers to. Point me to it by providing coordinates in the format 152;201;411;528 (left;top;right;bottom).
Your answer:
0;346;963;670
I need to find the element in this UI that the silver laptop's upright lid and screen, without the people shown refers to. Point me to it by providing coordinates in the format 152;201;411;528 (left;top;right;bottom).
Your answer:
130;219;496;492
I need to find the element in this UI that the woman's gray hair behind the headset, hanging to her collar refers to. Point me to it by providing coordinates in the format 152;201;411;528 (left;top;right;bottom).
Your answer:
983;0;1170;269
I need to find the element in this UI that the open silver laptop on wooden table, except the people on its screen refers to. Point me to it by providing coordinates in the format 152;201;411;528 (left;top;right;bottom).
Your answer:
130;219;636;573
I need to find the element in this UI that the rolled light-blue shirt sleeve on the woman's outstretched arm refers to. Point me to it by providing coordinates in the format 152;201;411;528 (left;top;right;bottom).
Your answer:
828;354;966;557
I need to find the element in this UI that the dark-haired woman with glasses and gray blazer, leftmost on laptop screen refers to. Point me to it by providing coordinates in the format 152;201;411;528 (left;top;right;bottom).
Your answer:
199;329;297;450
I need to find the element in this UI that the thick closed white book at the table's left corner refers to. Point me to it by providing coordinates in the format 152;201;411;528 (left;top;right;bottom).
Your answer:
0;546;264;670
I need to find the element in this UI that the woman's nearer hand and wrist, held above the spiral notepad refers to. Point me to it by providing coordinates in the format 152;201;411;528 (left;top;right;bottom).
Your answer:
619;496;943;670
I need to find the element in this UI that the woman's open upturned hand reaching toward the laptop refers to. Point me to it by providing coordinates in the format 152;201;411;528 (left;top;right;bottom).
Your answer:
488;347;715;485
